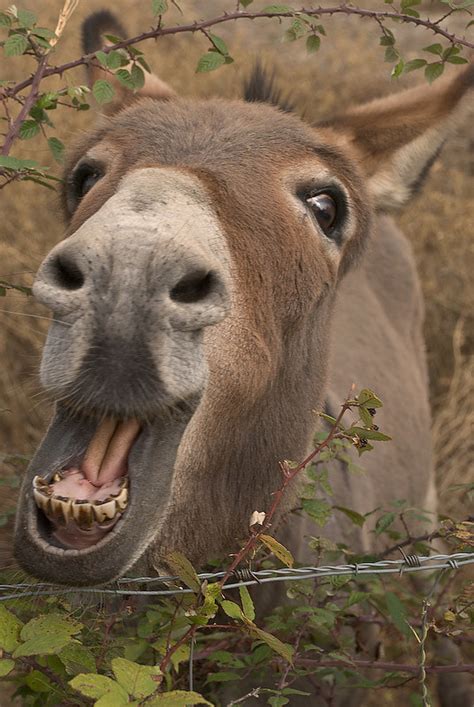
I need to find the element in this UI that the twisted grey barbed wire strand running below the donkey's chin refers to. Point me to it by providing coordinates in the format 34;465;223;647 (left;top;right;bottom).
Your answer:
0;552;474;601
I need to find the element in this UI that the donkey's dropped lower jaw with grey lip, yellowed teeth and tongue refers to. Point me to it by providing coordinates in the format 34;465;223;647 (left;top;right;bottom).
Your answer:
14;398;193;586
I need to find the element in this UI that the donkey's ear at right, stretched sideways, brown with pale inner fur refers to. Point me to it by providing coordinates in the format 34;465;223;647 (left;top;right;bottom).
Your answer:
325;64;474;210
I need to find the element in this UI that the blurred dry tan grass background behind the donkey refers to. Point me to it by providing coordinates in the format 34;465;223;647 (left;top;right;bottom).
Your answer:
0;0;474;517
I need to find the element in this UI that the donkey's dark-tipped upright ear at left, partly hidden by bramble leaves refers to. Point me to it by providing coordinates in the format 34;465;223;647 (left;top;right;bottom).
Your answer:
82;10;175;115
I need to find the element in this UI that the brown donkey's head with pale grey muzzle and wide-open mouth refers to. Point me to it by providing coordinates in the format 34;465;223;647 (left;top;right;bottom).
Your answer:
12;14;473;585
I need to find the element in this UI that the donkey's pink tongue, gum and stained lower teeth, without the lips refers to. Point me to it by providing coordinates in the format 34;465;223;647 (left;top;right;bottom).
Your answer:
32;418;140;550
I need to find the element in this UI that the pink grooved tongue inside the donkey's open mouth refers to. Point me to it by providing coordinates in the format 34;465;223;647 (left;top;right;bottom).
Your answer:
81;418;140;486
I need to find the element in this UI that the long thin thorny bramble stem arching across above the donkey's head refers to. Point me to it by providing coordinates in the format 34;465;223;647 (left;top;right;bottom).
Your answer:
0;4;474;105
